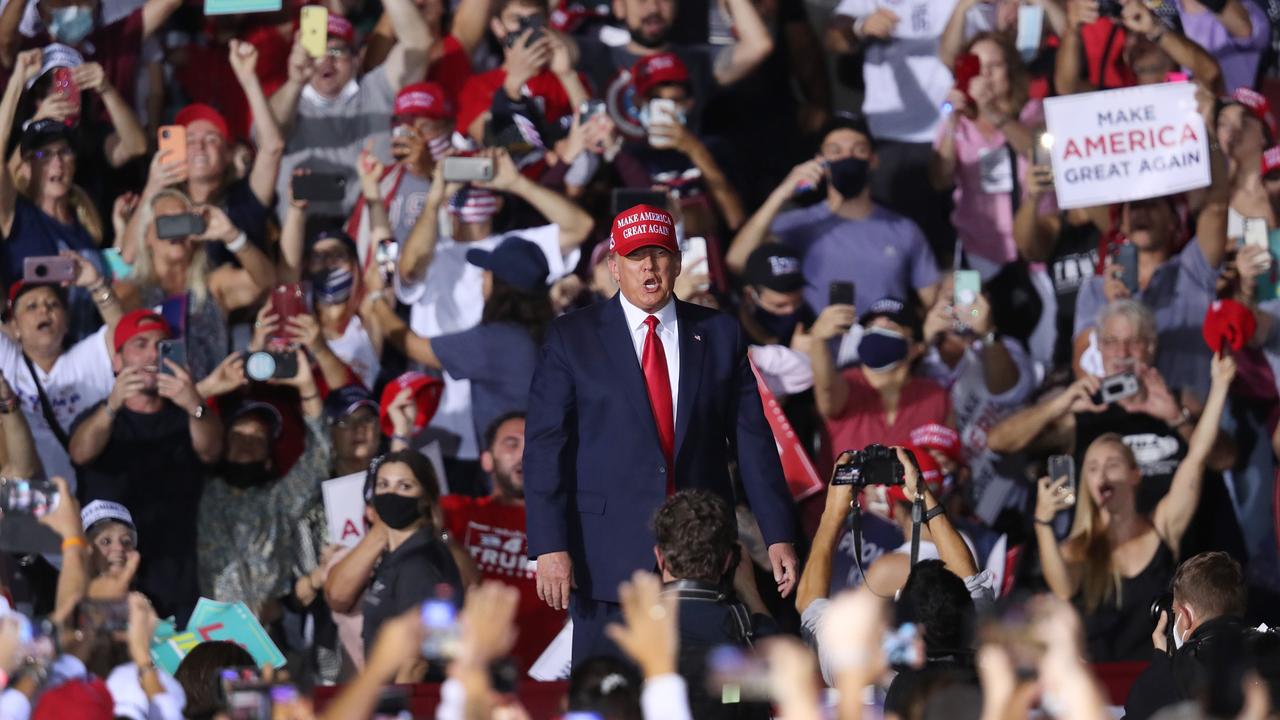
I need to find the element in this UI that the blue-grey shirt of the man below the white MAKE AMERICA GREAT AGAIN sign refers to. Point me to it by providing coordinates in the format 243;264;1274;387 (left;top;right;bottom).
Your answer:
1073;238;1217;397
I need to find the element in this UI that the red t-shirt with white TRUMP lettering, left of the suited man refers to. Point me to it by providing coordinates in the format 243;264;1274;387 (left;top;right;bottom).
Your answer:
440;495;564;670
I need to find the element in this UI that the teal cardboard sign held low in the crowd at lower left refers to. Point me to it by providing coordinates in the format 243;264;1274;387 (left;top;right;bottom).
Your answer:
151;597;284;675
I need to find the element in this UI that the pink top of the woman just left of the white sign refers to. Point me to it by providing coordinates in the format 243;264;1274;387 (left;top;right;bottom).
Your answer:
933;100;1057;266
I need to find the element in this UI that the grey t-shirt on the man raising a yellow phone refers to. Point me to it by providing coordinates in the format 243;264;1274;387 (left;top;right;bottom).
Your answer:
275;65;397;223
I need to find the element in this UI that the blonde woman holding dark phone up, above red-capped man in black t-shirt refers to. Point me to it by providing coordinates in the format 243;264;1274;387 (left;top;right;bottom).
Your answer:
116;188;275;378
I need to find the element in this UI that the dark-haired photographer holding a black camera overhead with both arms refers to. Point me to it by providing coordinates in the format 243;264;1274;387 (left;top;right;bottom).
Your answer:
796;445;992;682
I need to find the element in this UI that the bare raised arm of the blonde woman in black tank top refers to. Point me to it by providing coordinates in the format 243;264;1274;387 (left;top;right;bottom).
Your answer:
1152;354;1235;545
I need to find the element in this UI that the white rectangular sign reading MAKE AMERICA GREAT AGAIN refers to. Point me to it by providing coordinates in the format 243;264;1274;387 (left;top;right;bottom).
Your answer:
1044;82;1210;210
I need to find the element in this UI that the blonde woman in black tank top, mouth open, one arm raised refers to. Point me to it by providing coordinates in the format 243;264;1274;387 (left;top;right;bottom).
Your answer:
1036;355;1235;662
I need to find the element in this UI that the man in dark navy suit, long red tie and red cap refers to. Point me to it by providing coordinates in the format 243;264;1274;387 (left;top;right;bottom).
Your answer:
524;199;796;666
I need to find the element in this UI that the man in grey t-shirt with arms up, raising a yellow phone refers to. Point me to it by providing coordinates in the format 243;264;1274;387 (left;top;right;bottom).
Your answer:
271;0;433;223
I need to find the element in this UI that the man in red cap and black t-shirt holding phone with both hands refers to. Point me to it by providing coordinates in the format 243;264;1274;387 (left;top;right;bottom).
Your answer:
69;310;223;625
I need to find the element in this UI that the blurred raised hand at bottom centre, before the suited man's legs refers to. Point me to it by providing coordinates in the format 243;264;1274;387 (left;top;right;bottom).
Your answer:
601;570;680;679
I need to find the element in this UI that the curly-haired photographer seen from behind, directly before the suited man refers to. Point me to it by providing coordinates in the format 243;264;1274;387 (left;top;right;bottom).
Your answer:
653;489;777;720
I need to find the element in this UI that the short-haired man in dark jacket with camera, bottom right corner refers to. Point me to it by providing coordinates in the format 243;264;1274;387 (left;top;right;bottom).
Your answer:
1125;552;1251;720
